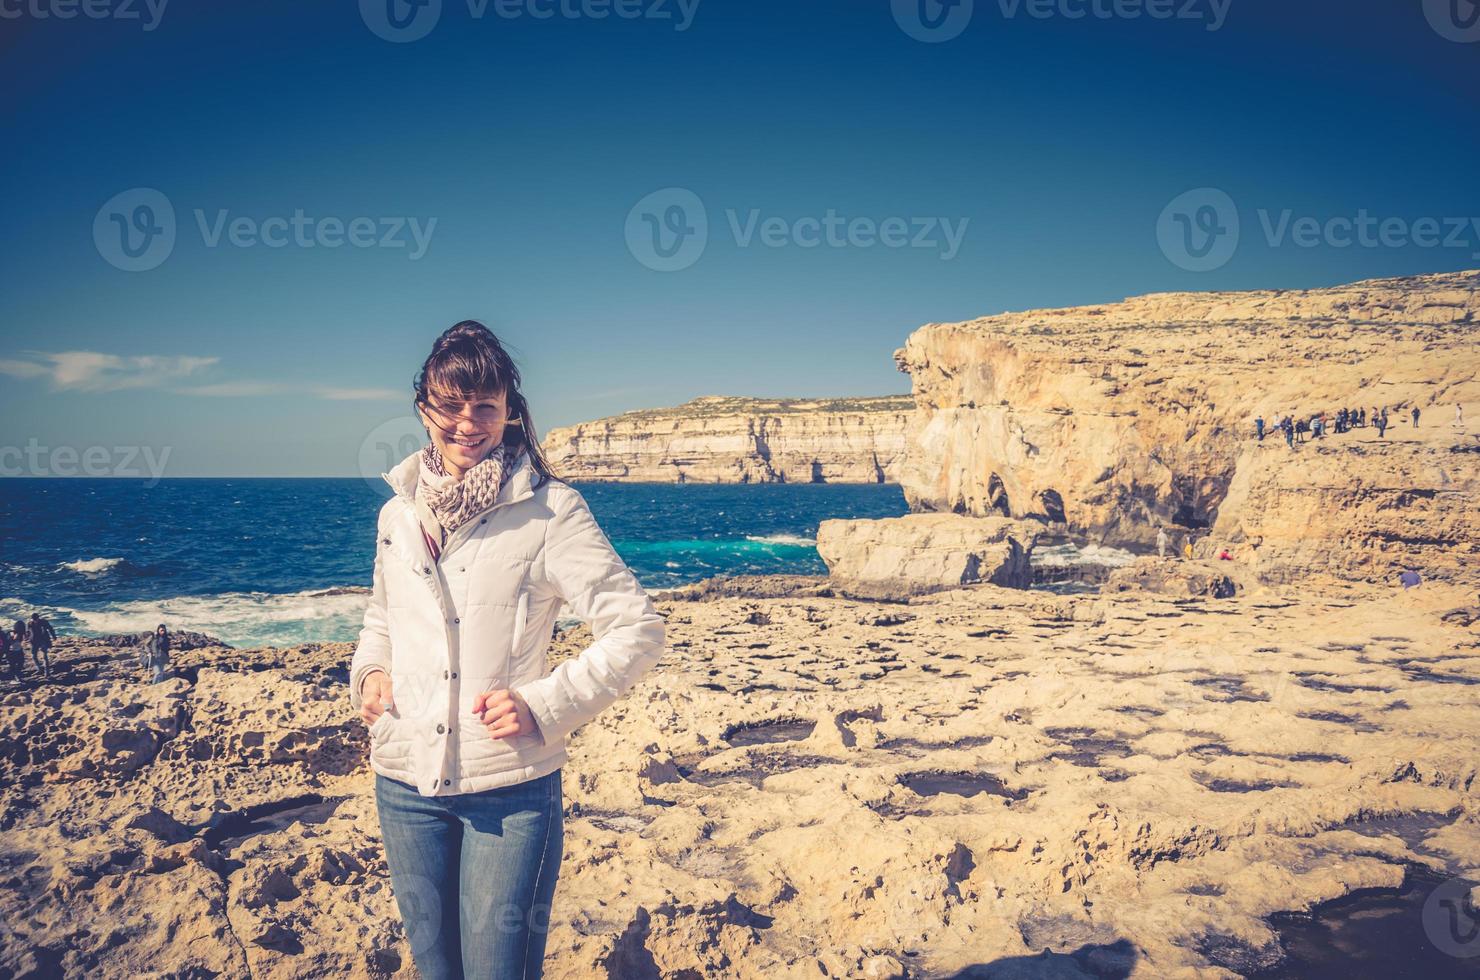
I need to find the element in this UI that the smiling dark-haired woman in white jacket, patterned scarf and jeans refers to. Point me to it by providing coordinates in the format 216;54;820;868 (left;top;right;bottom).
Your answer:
349;320;665;980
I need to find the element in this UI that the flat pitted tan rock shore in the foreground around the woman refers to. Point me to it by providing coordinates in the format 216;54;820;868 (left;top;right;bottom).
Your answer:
0;577;1480;979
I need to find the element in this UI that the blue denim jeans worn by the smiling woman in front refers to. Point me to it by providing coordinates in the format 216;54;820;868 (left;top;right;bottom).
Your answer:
374;770;565;980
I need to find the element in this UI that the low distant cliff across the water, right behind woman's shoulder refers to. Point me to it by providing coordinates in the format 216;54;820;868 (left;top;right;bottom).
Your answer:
542;395;913;483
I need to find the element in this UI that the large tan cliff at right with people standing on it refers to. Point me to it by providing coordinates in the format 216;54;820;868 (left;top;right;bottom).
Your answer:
894;272;1480;579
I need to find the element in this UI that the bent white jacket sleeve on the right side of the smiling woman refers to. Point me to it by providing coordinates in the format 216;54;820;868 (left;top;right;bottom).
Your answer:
514;487;665;745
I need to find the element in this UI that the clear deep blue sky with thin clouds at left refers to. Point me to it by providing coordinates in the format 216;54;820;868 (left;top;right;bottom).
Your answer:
0;0;1480;477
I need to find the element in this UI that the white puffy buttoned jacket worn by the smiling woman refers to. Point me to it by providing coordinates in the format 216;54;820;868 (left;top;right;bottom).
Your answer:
349;453;665;796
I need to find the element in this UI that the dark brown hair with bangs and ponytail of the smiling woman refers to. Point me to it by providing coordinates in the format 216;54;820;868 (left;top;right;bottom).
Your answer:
413;320;558;480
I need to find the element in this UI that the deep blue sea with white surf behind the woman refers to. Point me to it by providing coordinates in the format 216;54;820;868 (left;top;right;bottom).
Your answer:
0;478;907;647
